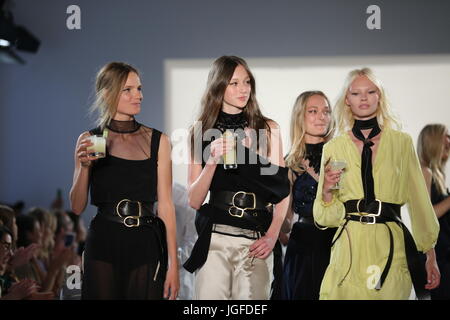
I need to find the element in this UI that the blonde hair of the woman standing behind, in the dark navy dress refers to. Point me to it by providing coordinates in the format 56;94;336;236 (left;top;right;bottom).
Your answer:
286;91;335;173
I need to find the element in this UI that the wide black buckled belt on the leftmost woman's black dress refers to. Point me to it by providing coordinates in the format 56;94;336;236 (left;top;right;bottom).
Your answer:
98;199;159;228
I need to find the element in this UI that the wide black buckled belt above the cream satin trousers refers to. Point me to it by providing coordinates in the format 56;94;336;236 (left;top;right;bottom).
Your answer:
209;191;273;231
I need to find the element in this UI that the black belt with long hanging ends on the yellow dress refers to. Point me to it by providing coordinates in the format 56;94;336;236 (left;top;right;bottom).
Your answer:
332;199;429;300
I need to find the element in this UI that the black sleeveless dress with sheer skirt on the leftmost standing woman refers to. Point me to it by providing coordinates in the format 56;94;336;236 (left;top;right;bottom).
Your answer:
82;125;167;299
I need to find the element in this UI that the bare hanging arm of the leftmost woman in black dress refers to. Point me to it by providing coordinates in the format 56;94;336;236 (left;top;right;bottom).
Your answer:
157;134;180;300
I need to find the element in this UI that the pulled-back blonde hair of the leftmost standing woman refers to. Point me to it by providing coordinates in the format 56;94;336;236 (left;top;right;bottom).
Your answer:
91;62;139;129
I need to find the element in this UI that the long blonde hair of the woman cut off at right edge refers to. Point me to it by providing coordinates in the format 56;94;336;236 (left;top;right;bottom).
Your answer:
417;123;447;194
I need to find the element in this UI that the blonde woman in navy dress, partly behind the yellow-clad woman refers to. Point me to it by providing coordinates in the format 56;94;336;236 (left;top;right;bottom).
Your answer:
282;91;336;300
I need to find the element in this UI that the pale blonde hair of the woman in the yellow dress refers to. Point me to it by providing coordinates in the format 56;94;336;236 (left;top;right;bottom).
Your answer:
335;68;401;134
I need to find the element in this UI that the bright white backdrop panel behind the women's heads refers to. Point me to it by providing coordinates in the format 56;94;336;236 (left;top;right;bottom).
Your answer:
165;55;450;189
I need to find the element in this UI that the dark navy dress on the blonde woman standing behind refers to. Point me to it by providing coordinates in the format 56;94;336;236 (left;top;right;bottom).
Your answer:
282;143;336;300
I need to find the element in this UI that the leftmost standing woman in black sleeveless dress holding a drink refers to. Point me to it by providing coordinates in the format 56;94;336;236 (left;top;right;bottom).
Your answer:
70;62;179;299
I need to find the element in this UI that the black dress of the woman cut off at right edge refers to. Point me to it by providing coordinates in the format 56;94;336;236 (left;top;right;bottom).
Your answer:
431;181;450;300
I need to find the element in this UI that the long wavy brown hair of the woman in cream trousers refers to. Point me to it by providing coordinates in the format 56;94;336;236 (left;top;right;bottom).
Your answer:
190;56;271;161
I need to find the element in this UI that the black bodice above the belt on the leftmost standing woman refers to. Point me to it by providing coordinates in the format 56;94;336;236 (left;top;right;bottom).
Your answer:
89;128;161;206
